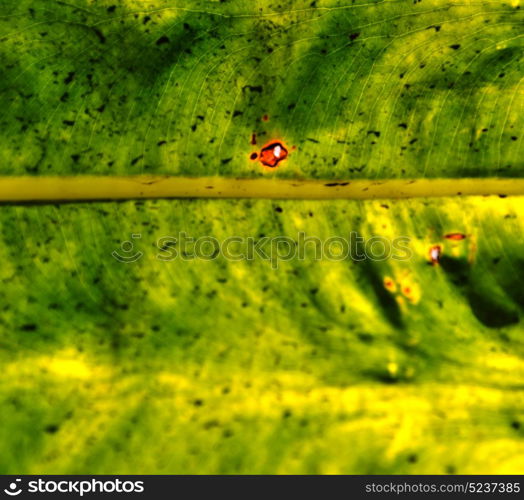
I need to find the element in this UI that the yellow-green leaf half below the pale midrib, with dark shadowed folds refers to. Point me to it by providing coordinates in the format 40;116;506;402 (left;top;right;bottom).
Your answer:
0;198;524;474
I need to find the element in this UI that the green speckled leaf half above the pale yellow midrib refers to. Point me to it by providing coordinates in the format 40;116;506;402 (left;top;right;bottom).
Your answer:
0;0;524;179
